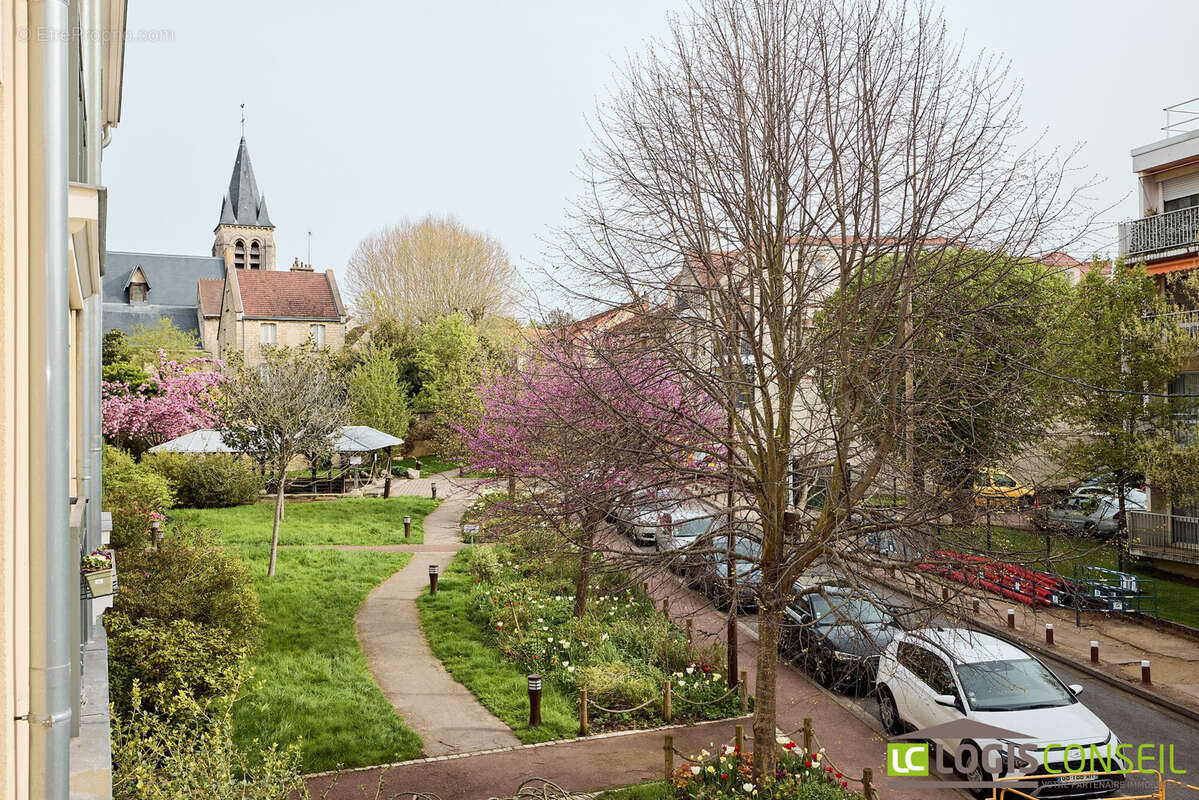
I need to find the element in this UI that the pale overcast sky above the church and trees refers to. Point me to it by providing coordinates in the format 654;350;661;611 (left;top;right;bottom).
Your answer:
104;0;1199;309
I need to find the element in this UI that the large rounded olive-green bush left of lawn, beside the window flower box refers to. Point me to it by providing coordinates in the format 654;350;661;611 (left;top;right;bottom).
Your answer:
113;525;263;645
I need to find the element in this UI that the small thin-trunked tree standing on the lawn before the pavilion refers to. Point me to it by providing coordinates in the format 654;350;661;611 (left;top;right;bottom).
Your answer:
221;348;345;577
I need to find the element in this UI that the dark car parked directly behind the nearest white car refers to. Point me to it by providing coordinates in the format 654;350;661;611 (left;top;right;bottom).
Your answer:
779;583;900;694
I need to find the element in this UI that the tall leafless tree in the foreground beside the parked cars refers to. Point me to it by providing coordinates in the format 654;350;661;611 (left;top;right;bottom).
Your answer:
559;0;1085;776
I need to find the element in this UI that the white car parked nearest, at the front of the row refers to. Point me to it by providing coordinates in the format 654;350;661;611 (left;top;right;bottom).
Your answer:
876;627;1126;798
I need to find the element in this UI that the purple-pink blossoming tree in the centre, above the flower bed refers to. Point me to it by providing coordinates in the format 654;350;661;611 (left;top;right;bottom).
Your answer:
459;342;716;618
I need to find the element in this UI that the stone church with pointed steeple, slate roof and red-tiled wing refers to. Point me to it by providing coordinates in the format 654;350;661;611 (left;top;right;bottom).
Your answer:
103;137;349;363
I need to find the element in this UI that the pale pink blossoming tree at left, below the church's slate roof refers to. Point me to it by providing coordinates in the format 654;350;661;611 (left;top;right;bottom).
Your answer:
103;350;224;453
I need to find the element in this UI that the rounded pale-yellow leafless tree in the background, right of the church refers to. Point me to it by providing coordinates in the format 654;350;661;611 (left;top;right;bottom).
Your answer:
348;216;516;325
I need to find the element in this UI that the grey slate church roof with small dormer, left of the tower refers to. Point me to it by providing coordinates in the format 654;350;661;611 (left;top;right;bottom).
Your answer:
102;251;224;335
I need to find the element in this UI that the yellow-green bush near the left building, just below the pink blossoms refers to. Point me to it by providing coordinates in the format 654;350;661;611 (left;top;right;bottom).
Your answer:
103;445;175;548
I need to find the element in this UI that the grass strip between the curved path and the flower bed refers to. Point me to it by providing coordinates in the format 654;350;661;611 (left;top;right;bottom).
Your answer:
416;548;579;744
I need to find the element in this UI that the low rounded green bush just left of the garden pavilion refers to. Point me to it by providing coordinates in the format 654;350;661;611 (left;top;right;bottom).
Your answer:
143;453;263;509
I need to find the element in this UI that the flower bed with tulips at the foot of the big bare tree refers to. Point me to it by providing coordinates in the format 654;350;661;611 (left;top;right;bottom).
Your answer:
671;739;862;800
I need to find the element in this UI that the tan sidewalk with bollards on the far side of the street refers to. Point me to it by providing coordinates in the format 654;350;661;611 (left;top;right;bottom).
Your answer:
888;575;1199;711
